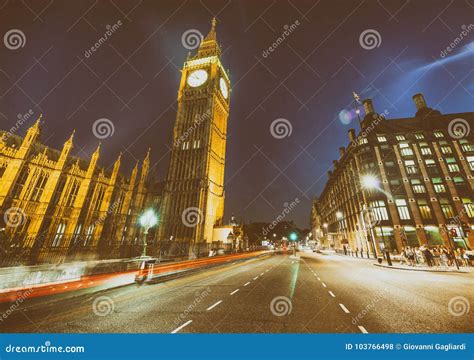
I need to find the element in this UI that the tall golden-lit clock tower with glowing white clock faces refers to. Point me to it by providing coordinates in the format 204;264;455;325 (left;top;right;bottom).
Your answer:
158;19;230;256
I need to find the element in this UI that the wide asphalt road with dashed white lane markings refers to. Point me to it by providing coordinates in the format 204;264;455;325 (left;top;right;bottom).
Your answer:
0;253;474;333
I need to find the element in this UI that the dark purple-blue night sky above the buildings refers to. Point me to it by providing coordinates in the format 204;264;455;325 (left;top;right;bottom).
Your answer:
0;0;474;227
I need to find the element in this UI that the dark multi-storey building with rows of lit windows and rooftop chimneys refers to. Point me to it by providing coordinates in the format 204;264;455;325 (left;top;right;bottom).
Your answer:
312;94;474;256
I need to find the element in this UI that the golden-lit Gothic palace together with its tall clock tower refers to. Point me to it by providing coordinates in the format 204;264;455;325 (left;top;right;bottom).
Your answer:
0;20;236;266
